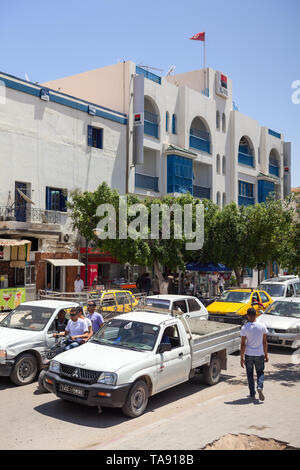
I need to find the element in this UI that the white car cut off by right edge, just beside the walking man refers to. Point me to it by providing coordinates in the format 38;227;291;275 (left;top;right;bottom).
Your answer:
257;297;300;349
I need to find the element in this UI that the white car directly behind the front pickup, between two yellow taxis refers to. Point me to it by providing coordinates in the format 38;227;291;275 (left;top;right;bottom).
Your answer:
146;294;208;320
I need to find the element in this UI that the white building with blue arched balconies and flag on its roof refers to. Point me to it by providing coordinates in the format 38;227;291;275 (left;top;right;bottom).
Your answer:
45;62;291;206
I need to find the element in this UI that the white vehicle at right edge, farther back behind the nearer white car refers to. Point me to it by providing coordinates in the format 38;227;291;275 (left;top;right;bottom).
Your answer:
259;276;300;300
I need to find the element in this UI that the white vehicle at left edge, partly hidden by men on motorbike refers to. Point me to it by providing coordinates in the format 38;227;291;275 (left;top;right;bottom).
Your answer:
0;300;79;385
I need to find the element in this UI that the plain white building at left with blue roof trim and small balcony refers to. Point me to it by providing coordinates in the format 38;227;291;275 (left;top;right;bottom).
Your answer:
0;73;127;291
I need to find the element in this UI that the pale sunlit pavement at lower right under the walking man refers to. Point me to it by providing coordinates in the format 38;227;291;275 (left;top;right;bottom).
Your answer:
95;349;300;450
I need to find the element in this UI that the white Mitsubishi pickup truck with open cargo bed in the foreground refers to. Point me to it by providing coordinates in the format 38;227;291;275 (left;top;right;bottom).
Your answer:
45;311;240;417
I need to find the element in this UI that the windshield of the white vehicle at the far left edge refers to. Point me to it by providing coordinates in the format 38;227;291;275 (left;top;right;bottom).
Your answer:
0;305;55;331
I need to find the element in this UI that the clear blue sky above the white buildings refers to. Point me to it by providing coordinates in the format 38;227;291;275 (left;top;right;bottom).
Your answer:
0;0;300;186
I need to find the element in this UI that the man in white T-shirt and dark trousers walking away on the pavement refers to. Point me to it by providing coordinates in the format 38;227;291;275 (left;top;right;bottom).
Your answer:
240;308;269;401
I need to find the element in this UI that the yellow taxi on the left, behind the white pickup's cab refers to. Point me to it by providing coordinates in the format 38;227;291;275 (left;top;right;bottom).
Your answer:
89;289;139;313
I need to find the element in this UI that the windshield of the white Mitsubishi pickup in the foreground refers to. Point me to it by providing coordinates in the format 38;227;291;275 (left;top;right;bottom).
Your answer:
91;319;160;351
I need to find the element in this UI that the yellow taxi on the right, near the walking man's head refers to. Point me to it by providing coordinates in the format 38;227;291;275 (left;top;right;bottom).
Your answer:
206;288;273;324
